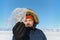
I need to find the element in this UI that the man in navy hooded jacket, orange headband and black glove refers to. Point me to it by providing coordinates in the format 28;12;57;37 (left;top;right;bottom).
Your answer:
13;9;47;40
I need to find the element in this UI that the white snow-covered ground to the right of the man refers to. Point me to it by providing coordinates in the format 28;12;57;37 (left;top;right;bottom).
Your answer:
44;31;60;40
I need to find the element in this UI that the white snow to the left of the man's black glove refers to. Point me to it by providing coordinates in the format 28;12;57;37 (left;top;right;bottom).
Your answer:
0;31;13;40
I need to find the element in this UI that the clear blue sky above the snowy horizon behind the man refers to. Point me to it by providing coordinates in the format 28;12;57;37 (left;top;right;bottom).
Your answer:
0;0;60;30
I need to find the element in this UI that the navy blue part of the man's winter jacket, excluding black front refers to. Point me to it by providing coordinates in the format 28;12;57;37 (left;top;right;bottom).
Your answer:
12;29;47;40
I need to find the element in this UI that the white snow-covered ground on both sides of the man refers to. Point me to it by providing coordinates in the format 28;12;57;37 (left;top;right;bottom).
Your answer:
0;31;60;40
